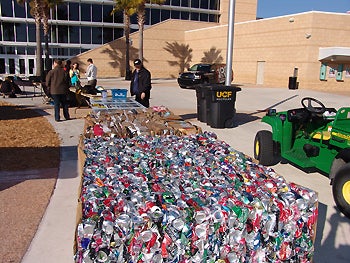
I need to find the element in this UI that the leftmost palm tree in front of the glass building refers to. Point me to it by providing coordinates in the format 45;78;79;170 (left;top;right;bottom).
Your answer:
16;0;45;76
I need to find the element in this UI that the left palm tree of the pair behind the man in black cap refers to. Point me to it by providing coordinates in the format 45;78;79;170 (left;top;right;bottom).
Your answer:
111;0;139;80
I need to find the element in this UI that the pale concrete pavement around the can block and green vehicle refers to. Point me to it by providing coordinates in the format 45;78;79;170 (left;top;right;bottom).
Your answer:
4;79;350;263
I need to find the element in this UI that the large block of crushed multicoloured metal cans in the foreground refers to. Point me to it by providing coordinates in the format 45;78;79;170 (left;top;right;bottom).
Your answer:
75;106;318;263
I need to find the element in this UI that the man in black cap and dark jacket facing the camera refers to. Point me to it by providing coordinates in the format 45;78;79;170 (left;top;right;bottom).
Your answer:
130;59;152;108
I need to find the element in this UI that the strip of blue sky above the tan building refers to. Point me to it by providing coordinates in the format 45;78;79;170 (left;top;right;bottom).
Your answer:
257;0;350;18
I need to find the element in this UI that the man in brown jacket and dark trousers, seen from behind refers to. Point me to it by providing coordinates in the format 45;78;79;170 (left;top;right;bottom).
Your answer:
46;59;70;121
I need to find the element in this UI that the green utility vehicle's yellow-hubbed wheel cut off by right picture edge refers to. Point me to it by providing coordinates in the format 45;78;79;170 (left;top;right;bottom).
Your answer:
332;163;350;218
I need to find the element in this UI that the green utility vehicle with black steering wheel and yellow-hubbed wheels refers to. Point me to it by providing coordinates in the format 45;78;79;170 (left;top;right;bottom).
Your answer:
254;97;350;218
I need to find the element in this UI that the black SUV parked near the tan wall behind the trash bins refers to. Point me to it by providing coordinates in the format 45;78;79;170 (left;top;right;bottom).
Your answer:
177;63;226;89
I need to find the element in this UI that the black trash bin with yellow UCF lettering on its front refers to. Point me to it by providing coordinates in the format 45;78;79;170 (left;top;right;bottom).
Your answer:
206;85;241;128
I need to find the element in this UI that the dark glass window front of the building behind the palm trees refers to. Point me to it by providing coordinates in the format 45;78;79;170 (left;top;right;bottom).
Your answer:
0;0;220;76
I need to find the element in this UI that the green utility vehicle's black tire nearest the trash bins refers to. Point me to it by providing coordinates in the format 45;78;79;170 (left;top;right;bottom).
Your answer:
254;130;275;165
